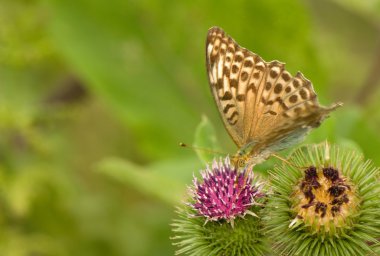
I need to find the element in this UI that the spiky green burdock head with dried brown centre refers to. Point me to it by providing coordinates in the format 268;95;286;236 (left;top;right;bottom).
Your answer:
265;143;380;256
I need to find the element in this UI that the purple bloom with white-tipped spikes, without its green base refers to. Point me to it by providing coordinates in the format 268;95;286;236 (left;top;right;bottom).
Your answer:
190;157;264;221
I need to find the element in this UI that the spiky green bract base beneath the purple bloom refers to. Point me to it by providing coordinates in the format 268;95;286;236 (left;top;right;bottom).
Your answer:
172;205;269;256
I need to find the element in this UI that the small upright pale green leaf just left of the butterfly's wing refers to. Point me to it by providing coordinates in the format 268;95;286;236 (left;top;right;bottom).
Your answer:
193;115;220;163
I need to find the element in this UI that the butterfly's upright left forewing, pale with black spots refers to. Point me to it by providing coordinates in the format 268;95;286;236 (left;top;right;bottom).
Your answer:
206;27;265;147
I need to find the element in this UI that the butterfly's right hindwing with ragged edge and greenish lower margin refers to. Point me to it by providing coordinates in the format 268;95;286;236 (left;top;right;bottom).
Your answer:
251;70;340;155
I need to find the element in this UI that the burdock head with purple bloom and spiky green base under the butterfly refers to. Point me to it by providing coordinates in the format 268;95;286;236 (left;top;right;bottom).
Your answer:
172;157;268;255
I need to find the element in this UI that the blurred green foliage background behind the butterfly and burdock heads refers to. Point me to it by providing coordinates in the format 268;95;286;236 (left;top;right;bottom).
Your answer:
0;0;380;256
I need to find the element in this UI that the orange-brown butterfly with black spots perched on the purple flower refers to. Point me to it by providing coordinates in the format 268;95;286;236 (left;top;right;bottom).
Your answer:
206;27;343;167
